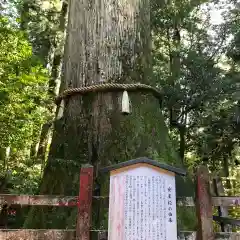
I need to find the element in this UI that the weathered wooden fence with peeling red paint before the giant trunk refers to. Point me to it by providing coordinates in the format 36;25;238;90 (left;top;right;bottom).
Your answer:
0;165;240;240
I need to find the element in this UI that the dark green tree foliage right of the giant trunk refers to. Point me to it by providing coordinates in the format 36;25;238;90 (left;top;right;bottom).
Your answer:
152;1;240;229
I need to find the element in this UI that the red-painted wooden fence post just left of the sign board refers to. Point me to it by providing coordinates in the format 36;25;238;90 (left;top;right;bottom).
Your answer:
76;164;93;240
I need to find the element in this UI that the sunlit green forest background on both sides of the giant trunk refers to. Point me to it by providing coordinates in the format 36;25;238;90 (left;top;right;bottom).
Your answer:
0;0;240;231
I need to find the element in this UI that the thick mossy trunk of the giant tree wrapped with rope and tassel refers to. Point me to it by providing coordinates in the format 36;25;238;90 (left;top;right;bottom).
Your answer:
26;0;181;228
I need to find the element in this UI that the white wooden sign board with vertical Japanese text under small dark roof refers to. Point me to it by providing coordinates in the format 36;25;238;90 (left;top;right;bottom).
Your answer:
101;159;186;240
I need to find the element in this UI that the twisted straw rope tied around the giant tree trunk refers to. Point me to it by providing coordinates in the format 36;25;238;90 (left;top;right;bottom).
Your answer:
55;83;162;104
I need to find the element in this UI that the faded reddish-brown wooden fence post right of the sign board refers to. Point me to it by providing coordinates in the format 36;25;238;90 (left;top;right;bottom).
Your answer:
196;166;214;240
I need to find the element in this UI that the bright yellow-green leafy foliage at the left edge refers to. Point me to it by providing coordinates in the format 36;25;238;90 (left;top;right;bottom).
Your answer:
0;18;49;151
